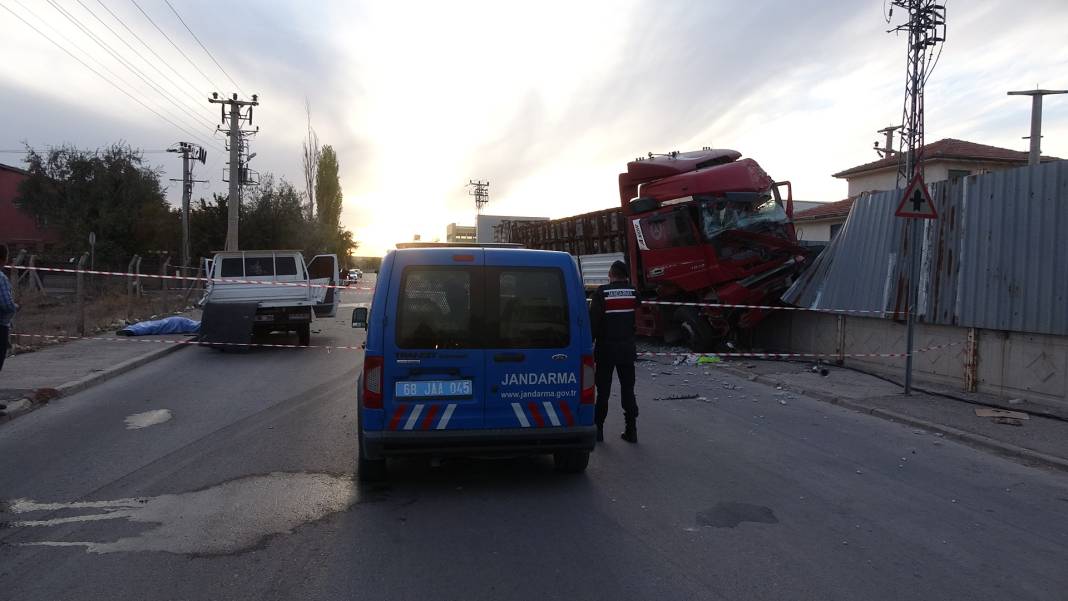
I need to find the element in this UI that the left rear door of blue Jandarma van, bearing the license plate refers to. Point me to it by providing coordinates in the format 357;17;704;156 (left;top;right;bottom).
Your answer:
382;249;485;430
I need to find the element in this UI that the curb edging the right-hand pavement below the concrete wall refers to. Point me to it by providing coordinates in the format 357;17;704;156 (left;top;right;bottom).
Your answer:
727;366;1068;472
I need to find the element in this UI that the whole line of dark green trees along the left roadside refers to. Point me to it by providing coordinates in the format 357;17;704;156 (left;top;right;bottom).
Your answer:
16;144;358;265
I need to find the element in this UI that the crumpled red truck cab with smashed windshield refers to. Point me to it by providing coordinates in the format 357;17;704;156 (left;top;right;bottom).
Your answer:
619;148;807;350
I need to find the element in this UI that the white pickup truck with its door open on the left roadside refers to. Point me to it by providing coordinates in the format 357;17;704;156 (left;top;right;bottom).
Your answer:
201;251;340;346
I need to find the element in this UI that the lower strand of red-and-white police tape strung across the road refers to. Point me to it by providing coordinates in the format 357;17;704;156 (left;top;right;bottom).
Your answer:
12;334;963;359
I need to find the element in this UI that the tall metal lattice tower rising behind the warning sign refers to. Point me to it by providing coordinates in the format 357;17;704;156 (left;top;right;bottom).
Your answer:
890;0;945;188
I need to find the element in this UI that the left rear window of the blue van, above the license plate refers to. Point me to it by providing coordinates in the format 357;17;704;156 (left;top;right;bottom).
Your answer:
396;267;480;349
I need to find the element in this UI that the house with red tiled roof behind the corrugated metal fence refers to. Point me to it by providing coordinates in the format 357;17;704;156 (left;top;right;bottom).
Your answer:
794;138;1059;242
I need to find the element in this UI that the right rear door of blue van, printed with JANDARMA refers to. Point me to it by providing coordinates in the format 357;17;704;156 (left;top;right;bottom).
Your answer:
485;258;585;428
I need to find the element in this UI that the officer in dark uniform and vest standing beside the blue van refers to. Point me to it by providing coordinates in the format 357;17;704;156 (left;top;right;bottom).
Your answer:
590;260;639;443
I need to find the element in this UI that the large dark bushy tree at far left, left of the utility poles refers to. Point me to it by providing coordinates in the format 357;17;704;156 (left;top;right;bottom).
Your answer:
16;143;178;263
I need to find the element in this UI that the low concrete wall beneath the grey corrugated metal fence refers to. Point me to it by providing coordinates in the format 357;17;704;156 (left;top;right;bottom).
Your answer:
754;312;1068;409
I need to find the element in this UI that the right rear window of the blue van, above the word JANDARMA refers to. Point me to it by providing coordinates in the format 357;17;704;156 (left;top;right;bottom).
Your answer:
490;268;570;348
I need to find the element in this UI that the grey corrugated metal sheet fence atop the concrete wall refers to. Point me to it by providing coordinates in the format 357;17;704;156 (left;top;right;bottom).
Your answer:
783;161;1068;335
